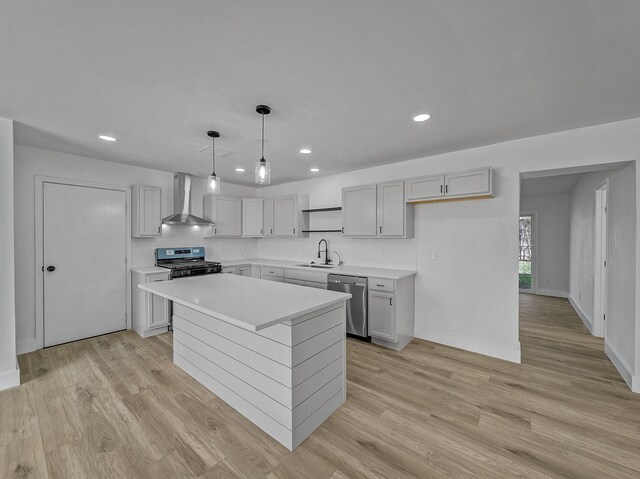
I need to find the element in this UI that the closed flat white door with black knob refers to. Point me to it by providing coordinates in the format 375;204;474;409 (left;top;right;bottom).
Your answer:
43;183;127;347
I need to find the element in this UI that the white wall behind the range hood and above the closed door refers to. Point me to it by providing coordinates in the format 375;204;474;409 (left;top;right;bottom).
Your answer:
13;145;257;353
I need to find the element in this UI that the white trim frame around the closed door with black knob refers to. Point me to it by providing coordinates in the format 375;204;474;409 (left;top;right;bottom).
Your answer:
34;175;131;349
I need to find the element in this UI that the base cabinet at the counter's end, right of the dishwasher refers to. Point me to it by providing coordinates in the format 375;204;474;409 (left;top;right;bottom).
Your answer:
368;276;415;350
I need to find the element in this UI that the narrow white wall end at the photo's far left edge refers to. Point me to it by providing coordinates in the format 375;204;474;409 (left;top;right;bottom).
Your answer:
0;118;20;390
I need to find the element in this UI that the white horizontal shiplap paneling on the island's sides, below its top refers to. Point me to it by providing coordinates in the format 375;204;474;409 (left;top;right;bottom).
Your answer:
173;302;346;450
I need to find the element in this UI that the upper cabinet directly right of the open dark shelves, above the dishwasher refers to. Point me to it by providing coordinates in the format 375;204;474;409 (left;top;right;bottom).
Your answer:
342;185;378;237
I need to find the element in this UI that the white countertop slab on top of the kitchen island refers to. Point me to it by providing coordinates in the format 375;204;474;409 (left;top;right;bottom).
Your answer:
138;274;351;332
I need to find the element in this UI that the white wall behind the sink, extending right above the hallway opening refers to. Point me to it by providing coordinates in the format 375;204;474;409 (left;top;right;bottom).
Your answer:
258;119;640;361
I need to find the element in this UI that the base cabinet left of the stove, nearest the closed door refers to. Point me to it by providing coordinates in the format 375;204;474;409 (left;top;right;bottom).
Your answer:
131;268;171;338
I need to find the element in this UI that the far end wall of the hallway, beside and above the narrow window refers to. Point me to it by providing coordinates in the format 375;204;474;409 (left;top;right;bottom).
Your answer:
520;193;571;297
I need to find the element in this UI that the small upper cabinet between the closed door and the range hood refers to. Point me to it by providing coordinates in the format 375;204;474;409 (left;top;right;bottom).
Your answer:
131;186;162;238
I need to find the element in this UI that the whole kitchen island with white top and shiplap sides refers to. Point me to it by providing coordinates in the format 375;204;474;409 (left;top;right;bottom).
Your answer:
138;274;351;450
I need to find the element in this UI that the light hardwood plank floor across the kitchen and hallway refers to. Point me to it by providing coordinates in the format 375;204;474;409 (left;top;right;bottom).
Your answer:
0;295;640;479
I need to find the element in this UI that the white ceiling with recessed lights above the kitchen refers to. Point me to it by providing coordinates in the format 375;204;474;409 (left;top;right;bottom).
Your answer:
0;0;640;183
